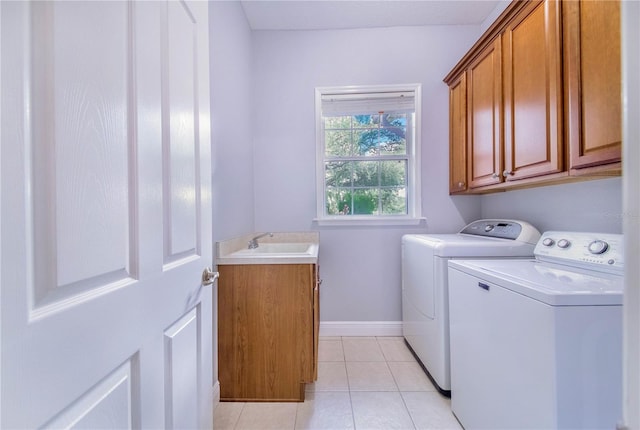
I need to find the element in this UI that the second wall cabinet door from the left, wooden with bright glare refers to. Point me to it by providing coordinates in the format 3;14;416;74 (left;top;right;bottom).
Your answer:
467;36;502;188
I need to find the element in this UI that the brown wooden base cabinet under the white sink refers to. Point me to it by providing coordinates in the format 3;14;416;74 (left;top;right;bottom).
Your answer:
218;264;319;401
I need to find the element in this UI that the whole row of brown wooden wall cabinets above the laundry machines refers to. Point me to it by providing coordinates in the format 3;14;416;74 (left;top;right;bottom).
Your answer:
444;0;622;194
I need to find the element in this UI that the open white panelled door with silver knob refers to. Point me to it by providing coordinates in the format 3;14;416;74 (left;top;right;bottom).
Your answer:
0;1;213;429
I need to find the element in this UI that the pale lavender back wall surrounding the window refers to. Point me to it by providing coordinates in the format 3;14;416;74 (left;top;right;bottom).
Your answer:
253;26;480;321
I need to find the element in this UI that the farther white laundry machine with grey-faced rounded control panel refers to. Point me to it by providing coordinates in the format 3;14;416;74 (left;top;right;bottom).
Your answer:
402;219;540;395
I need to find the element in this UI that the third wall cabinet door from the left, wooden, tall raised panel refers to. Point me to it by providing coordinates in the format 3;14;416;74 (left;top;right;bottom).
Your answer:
503;0;564;181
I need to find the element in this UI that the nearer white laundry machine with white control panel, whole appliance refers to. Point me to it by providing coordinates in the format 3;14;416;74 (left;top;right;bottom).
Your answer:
449;232;624;429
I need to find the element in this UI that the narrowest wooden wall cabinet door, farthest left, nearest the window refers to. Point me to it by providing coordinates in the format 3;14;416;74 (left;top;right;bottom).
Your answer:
449;73;467;194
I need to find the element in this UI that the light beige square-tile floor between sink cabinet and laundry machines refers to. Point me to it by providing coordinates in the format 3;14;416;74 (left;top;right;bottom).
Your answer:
213;337;461;430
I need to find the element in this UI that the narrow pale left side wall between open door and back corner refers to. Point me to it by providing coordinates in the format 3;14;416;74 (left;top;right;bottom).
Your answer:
209;1;254;242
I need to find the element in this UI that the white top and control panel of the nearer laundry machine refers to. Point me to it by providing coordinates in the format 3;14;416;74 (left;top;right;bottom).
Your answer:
449;231;624;306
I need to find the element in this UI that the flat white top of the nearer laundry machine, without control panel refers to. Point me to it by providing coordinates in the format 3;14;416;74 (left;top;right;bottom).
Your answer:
449;260;623;306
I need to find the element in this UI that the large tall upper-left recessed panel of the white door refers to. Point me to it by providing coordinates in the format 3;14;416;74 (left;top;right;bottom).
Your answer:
25;2;138;318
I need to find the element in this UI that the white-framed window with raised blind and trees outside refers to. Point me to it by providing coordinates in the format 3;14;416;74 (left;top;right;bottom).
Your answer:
316;85;421;224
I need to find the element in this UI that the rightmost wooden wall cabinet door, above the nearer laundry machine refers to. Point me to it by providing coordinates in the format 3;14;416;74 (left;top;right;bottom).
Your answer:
563;0;622;169
